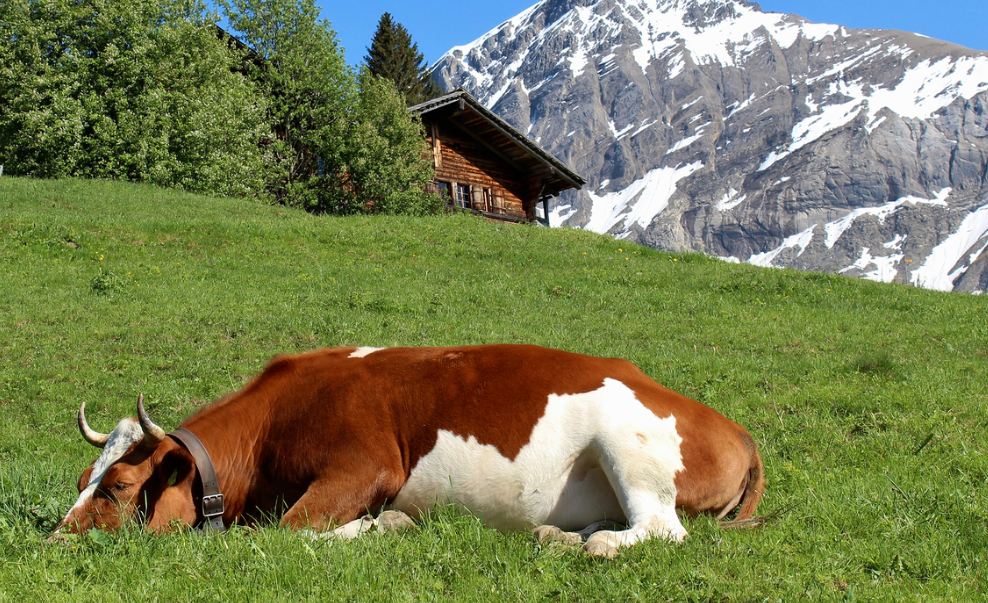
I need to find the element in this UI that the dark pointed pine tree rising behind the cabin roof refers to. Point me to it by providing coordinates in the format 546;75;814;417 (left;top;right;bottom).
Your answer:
364;13;441;105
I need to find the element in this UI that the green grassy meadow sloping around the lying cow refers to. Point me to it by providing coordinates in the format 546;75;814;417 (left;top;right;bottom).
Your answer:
0;178;988;601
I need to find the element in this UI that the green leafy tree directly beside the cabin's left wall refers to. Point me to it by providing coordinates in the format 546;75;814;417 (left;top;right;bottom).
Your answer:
223;0;435;213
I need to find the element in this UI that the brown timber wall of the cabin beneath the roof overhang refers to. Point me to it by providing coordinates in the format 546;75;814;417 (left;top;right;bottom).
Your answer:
425;121;538;220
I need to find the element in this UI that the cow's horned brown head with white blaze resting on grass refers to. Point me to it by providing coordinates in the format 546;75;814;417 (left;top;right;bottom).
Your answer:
55;396;196;534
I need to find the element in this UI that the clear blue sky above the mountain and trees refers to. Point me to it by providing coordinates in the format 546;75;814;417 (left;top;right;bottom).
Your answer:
316;0;988;64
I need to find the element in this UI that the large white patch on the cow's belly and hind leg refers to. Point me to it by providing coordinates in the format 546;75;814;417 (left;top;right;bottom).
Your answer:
391;379;686;542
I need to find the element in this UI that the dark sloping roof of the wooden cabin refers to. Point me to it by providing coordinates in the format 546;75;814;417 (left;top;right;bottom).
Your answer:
409;89;587;195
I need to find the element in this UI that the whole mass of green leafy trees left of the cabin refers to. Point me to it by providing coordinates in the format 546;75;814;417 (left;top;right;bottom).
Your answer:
0;0;436;213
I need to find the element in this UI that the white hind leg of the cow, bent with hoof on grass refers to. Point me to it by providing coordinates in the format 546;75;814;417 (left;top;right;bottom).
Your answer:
583;416;686;558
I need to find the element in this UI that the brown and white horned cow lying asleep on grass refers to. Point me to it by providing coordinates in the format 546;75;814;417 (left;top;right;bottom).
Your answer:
56;344;765;557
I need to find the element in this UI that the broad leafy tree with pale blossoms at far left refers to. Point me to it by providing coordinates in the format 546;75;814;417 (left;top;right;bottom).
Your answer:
0;0;267;195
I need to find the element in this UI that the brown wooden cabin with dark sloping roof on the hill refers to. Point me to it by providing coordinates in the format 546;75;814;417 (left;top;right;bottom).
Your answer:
409;90;586;223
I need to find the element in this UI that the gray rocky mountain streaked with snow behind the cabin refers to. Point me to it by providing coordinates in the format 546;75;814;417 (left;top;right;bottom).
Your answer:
433;0;988;292
